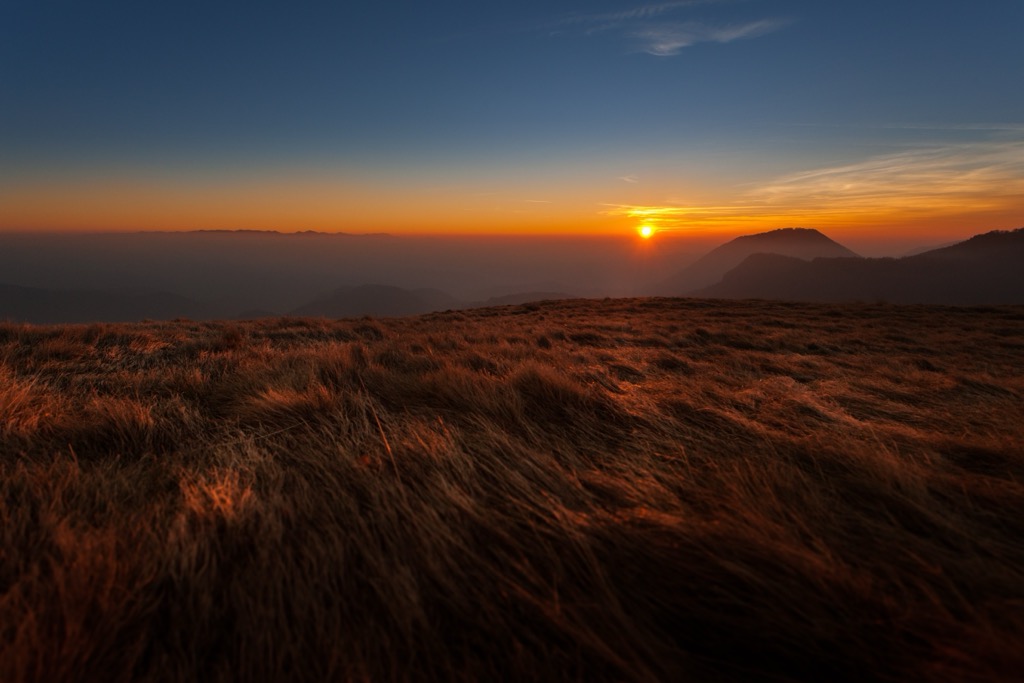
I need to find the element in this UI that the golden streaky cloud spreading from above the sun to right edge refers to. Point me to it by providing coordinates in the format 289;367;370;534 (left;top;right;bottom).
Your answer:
604;140;1024;230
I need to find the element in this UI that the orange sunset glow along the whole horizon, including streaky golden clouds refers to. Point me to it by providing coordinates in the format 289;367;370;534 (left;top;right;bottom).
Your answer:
0;142;1024;241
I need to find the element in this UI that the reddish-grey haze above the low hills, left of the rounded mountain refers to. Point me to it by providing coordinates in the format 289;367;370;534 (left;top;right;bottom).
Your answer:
0;230;696;317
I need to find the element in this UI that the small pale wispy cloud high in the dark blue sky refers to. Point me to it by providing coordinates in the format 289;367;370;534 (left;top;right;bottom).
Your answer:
548;0;790;56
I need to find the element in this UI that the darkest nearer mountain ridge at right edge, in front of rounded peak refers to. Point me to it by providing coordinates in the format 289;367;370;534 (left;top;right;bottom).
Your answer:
693;228;1024;305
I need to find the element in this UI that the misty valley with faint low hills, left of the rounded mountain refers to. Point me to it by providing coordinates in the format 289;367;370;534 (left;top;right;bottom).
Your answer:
0;230;696;323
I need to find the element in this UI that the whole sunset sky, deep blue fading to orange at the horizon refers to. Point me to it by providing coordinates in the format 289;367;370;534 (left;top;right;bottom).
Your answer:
0;0;1024;247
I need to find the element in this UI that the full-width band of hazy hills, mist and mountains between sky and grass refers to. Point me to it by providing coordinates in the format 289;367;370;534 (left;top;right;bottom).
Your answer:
0;228;1024;324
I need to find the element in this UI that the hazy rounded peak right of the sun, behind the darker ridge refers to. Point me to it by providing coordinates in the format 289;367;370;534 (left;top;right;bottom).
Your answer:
656;227;857;296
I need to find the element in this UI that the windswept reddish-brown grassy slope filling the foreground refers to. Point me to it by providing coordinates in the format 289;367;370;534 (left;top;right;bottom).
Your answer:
0;300;1024;682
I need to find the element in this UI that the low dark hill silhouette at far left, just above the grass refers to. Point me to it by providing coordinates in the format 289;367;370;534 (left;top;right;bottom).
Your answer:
0;285;211;324
